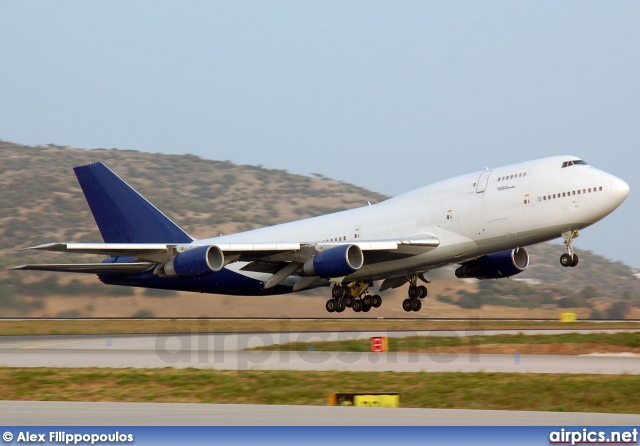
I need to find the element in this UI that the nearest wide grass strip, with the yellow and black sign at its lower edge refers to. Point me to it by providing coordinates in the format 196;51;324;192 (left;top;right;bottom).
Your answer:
0;368;640;413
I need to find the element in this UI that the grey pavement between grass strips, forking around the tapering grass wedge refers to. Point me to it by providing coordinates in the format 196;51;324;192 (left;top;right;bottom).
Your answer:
0;330;640;374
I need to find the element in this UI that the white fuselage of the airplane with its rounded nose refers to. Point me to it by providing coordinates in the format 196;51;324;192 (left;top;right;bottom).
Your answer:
197;156;629;280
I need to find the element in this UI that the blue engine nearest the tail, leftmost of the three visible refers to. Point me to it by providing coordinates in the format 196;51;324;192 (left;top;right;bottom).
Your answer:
163;246;224;279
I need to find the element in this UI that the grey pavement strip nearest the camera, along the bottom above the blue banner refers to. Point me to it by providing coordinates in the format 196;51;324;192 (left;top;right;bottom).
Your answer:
0;401;640;426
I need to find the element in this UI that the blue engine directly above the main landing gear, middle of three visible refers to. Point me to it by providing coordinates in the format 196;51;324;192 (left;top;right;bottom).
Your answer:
302;245;364;278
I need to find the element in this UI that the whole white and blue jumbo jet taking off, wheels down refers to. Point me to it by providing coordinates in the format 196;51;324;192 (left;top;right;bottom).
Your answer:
14;156;629;312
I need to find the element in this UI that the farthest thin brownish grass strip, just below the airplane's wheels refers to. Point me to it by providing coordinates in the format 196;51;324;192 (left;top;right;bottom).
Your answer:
0;319;640;336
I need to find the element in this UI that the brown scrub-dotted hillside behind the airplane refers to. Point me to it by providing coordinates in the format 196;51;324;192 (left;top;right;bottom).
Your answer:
0;141;640;317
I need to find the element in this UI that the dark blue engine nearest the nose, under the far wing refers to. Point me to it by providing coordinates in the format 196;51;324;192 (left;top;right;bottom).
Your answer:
456;248;529;280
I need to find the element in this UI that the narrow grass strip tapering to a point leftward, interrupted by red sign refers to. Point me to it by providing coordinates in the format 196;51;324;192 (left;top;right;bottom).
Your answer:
255;332;640;352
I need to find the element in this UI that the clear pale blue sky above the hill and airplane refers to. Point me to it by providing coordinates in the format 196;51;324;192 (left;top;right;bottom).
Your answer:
0;0;640;268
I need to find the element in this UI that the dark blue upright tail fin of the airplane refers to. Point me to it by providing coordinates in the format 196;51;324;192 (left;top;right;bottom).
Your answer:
73;163;193;243
